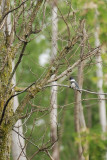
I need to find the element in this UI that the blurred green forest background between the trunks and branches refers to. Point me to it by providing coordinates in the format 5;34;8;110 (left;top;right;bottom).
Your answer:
5;0;107;160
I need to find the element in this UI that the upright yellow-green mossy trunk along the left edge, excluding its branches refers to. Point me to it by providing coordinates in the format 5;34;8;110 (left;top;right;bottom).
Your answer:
0;0;13;160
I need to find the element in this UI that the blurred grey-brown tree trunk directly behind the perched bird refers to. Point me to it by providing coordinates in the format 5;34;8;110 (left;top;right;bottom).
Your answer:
75;21;89;160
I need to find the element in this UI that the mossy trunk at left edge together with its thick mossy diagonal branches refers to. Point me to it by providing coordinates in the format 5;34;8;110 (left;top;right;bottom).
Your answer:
0;0;44;160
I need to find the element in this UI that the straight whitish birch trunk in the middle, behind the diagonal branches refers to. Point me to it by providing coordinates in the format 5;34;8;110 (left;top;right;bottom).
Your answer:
50;3;59;160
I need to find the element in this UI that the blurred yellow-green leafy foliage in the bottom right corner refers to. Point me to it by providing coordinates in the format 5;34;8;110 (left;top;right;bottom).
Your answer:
75;128;107;160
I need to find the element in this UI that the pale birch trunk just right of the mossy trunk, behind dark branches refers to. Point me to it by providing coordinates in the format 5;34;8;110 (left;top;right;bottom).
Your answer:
12;61;26;160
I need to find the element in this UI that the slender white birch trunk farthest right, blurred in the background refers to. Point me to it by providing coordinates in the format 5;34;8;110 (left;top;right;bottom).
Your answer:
94;8;107;132
